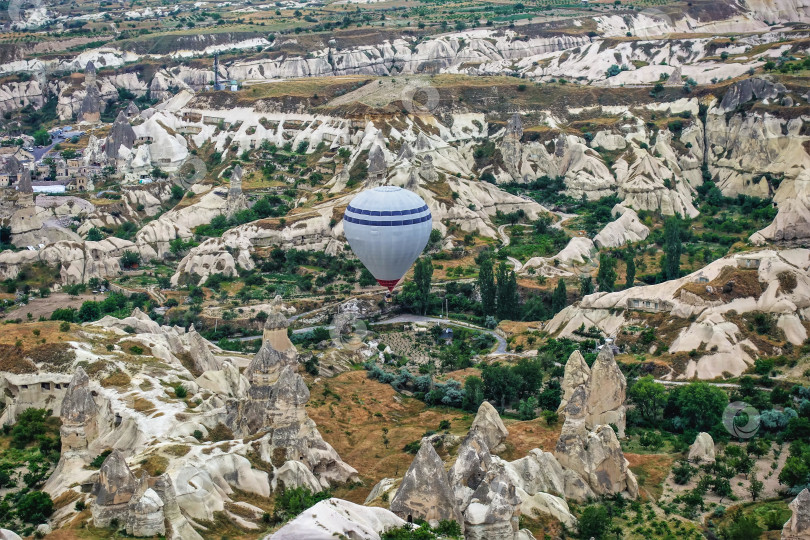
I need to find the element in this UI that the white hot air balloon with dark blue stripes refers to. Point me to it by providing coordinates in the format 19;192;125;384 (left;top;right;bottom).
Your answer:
343;186;433;291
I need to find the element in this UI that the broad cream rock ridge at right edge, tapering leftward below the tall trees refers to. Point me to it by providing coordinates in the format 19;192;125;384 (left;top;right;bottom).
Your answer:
545;249;810;378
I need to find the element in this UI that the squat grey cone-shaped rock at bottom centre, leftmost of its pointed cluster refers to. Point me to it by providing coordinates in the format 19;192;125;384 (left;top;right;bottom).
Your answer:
391;444;464;526
